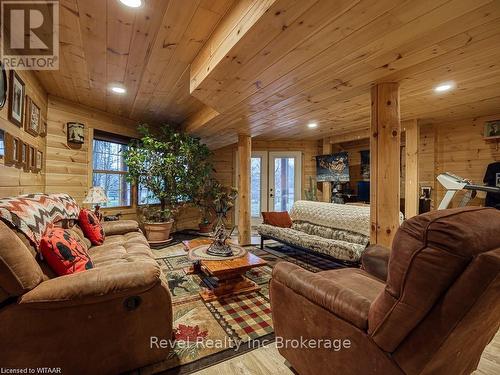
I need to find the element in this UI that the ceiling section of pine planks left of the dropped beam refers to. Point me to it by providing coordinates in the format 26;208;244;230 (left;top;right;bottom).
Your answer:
37;0;235;123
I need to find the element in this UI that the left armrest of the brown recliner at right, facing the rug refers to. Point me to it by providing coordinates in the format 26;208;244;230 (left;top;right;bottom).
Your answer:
271;262;379;330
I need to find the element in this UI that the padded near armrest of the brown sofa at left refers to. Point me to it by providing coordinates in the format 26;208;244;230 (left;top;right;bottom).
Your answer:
19;262;160;304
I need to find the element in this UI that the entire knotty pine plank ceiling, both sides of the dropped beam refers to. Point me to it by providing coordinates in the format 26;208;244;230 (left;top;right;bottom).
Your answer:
34;0;500;148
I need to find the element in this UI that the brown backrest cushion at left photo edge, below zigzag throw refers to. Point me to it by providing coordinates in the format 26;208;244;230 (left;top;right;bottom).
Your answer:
0;220;44;302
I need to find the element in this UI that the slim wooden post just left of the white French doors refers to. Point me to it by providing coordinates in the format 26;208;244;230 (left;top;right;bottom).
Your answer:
238;135;252;245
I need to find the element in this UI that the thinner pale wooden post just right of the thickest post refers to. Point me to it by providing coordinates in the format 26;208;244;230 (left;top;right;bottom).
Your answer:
403;120;420;219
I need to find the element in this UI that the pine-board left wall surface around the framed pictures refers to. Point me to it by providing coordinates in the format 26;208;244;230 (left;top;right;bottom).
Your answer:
0;71;47;197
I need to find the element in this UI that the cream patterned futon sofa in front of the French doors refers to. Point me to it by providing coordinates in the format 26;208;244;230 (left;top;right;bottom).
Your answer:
257;201;378;263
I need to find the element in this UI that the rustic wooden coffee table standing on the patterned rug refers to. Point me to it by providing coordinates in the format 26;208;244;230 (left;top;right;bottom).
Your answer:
183;239;267;302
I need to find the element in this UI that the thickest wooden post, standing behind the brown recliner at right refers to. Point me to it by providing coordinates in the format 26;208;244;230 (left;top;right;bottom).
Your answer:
370;83;401;247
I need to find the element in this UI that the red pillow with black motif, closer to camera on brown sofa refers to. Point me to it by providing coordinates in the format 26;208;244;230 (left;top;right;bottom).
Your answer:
40;228;94;276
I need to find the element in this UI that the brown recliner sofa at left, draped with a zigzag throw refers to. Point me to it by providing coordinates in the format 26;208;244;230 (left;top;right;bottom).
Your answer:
0;220;172;374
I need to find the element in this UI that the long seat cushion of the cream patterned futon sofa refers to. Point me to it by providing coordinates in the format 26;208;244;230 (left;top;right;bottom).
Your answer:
257;224;366;262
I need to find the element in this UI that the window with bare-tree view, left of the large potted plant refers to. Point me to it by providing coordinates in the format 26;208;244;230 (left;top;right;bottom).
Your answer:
93;139;131;207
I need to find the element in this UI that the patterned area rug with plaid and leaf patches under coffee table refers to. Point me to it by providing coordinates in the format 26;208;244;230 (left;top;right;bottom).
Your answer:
136;239;348;374
